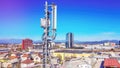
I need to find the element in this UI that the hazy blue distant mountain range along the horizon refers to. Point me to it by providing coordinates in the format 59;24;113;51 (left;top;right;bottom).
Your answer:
0;39;119;44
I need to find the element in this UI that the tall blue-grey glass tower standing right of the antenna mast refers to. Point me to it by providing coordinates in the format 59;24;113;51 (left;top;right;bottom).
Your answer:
66;33;74;48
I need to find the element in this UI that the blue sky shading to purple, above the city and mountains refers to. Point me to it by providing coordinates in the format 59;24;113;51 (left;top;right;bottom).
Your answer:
0;0;120;41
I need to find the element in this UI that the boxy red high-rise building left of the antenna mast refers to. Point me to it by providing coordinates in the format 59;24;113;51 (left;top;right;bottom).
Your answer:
22;39;33;50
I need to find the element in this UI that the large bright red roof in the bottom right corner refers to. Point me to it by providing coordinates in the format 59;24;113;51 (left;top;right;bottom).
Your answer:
104;58;120;68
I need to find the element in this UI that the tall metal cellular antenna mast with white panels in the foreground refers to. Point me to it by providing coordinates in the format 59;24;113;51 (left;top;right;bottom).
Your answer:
41;1;57;68
